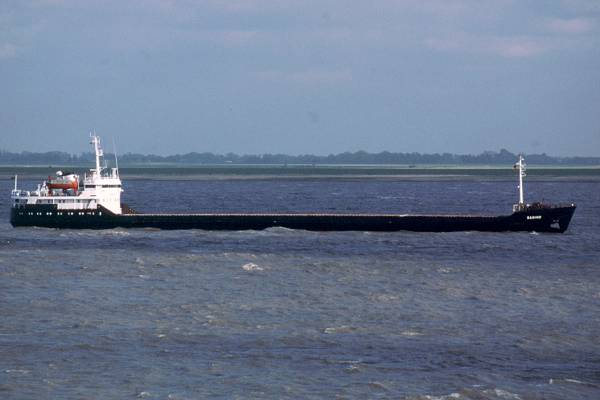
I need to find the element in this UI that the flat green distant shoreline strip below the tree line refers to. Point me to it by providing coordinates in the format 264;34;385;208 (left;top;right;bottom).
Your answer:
0;164;600;181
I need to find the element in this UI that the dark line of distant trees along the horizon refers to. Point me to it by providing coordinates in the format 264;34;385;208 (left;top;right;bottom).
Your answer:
0;149;600;166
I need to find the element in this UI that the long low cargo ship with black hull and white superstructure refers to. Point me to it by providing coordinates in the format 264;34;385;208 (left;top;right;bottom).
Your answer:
10;133;575;233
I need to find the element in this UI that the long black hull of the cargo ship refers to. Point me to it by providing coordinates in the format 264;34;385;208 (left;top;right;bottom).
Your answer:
10;205;575;233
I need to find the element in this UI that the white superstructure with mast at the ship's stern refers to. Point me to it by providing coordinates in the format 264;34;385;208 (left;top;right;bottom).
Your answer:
11;133;123;214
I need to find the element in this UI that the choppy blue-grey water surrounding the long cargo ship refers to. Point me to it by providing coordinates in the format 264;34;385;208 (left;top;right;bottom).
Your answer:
0;179;600;399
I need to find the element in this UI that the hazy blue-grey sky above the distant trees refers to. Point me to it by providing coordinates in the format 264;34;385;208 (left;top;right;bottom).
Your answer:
0;0;600;156
